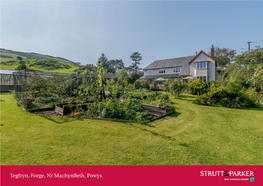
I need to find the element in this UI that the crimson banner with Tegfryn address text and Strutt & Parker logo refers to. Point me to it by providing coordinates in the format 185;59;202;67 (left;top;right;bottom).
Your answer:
1;166;263;186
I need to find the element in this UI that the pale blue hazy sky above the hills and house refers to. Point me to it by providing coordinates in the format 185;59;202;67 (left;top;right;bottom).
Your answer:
1;1;263;68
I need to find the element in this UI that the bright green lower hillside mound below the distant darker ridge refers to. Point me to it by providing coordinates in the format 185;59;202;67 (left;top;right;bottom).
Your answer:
0;58;78;73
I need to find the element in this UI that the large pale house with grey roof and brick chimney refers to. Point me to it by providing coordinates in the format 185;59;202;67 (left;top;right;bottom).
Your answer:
140;45;216;83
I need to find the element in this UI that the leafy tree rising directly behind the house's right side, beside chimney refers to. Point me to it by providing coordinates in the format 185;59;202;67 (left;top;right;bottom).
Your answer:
209;46;236;69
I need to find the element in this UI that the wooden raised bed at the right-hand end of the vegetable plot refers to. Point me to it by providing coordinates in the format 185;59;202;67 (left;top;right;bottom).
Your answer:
142;104;175;116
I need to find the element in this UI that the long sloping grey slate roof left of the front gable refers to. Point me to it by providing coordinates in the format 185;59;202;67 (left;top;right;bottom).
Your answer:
144;55;196;70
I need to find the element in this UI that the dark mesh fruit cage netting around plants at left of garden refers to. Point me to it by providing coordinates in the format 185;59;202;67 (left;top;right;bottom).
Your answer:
13;70;114;110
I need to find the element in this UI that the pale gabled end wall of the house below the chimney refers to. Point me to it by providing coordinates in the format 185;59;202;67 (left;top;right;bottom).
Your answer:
190;53;216;81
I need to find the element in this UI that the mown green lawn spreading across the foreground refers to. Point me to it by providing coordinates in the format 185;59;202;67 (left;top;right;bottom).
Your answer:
1;93;263;165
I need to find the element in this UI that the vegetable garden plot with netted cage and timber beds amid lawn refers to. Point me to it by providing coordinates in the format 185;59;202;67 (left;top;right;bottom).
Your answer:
13;69;174;123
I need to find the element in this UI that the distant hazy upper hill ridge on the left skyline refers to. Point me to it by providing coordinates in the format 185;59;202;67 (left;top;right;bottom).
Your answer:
0;49;78;64
